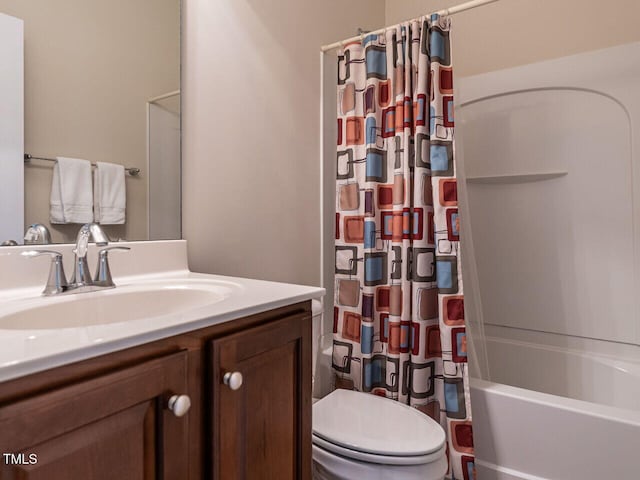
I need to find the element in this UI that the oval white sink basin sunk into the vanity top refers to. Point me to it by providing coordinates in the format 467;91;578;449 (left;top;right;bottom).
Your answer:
0;281;235;330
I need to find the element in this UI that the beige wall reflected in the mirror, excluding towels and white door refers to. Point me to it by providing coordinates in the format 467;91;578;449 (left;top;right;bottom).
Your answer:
0;0;181;244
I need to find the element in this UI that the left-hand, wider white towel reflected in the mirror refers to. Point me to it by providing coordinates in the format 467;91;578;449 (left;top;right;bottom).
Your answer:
49;157;93;223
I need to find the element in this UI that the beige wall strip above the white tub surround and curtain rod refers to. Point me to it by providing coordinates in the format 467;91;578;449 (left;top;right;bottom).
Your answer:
385;0;640;76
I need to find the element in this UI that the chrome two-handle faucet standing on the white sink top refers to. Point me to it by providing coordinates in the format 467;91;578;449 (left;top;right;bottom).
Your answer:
22;223;130;296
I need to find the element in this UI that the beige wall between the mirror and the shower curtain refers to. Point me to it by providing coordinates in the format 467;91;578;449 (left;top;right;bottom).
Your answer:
183;0;384;284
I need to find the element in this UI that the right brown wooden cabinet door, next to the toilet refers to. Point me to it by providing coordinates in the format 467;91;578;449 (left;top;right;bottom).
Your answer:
211;314;311;480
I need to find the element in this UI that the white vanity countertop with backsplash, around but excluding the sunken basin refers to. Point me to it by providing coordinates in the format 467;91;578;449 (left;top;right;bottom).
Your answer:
0;240;324;381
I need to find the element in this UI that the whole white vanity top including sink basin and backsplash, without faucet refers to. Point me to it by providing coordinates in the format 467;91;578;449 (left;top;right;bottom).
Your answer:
0;240;325;384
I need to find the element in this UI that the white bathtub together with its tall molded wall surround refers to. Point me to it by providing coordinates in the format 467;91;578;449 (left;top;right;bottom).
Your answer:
456;42;640;480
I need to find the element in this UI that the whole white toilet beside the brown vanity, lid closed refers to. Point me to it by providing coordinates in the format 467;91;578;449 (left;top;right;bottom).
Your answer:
313;390;448;480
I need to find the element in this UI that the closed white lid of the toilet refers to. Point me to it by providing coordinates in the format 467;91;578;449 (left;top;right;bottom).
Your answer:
313;390;445;457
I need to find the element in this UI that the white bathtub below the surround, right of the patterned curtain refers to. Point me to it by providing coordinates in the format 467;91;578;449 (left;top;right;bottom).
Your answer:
470;329;640;480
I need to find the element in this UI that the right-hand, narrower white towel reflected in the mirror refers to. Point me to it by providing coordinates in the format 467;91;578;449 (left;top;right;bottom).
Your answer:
93;162;127;225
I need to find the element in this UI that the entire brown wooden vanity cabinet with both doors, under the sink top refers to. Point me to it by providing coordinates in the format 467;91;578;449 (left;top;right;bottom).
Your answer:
0;302;311;480
